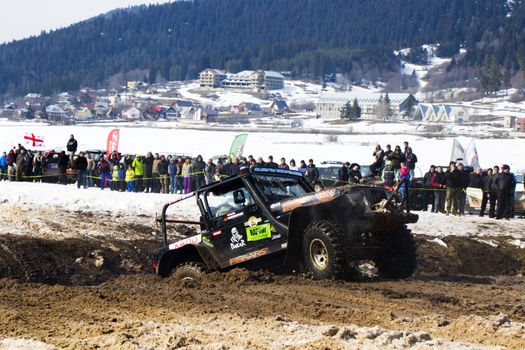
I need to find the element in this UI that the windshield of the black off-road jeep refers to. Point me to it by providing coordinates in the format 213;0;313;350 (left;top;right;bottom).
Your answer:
255;175;308;204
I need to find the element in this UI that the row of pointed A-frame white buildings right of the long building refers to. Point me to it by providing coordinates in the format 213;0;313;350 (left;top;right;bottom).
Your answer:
416;103;470;123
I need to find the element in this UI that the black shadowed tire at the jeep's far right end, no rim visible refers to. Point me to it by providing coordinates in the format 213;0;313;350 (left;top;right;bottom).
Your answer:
374;225;417;279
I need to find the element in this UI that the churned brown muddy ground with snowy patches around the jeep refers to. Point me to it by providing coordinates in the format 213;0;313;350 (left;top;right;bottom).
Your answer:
0;207;525;349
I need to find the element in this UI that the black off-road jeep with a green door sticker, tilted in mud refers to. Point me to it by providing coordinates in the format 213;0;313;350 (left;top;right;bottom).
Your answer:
153;168;418;279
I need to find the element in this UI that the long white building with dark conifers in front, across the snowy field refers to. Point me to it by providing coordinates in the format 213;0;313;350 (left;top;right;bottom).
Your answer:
315;91;417;119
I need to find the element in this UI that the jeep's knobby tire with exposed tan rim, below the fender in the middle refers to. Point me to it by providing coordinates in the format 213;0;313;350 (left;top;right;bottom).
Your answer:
303;221;345;279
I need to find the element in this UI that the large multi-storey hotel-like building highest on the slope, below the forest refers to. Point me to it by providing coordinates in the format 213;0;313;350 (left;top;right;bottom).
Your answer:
199;68;284;91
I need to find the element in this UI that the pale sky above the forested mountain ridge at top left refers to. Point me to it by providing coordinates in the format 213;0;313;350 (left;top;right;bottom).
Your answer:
0;0;171;43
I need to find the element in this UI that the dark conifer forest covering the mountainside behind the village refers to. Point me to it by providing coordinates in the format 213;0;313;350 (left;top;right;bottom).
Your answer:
0;0;525;95
